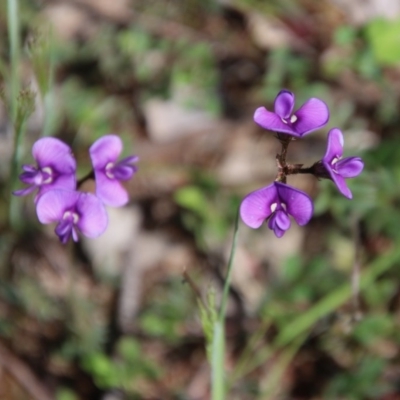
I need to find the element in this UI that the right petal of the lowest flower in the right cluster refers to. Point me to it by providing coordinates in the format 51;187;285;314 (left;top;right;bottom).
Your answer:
275;182;314;226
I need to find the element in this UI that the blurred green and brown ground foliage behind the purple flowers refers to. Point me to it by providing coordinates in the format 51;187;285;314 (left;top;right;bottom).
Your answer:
0;0;400;400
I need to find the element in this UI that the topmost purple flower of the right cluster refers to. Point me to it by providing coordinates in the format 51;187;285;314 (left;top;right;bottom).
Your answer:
254;90;329;137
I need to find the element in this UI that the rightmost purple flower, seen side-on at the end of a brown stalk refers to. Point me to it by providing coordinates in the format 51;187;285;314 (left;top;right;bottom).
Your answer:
320;128;364;199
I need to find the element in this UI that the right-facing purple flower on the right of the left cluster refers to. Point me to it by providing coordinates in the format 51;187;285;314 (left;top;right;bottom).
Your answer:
89;135;138;207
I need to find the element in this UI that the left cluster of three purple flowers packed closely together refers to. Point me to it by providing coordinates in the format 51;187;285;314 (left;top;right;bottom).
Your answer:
13;135;138;243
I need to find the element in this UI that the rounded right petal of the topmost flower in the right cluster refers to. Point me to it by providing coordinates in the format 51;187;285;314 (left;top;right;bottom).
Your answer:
293;97;329;136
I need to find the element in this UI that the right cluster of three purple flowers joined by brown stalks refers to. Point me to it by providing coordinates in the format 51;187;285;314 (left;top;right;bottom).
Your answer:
240;90;364;238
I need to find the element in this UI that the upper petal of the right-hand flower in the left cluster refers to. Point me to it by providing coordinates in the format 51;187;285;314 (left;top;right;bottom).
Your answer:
89;135;122;169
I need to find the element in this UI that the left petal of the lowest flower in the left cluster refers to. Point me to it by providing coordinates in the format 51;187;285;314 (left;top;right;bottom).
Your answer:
36;189;79;224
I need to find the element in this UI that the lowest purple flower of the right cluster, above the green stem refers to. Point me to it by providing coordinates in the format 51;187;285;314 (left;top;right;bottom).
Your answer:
240;182;314;238
